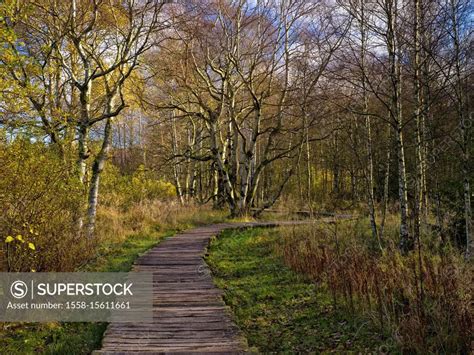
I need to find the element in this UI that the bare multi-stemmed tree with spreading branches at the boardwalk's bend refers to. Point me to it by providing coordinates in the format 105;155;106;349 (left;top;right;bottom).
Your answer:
146;1;341;216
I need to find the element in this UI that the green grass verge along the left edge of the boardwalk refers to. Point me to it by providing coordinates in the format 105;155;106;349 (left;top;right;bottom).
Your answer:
0;208;227;355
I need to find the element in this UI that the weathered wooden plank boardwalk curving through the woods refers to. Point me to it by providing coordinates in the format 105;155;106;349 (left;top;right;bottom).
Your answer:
94;221;298;354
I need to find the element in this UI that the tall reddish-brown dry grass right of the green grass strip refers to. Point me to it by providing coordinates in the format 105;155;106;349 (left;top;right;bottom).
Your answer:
277;222;473;353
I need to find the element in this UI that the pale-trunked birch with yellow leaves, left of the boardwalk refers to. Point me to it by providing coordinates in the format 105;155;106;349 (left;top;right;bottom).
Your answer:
2;0;164;238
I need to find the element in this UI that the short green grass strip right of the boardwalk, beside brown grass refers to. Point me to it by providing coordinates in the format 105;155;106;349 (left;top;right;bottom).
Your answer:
207;229;388;353
